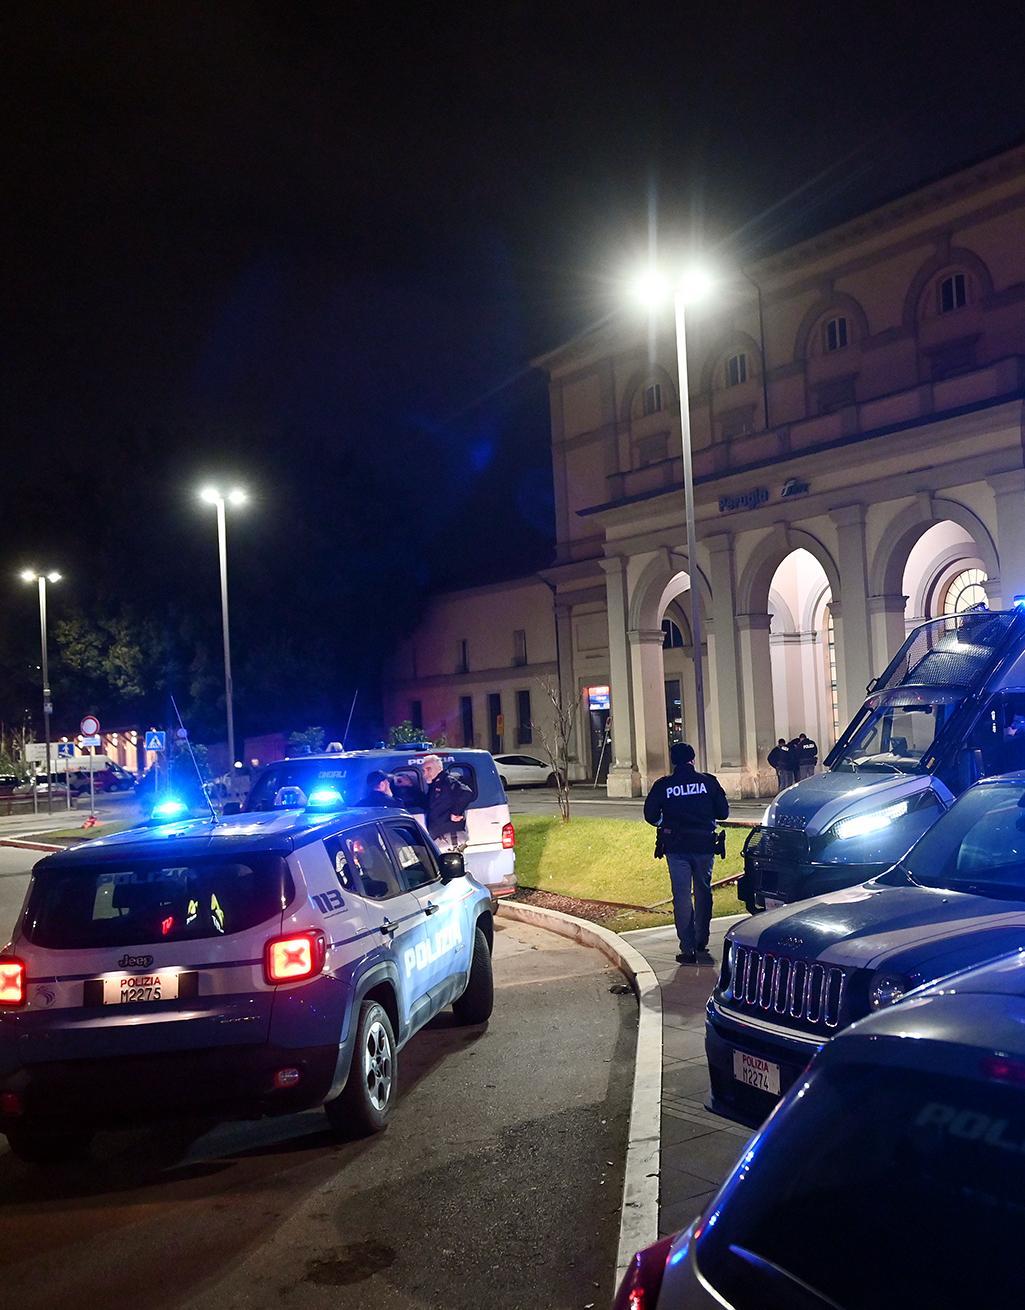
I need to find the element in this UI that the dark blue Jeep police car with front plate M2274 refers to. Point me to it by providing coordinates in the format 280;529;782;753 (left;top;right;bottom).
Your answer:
705;772;1025;1127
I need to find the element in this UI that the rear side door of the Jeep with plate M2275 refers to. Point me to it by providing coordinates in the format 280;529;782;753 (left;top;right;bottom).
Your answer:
324;823;425;1040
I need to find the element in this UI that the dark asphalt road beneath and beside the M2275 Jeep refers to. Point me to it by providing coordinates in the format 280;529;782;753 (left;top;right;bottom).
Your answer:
0;890;636;1310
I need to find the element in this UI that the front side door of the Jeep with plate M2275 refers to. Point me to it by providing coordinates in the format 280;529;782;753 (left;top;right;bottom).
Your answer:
384;819;473;1023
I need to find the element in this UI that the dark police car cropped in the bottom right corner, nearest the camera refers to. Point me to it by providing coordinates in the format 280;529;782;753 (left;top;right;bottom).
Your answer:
616;951;1025;1310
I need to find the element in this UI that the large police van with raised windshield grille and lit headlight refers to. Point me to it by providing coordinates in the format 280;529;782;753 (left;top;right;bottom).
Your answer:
739;608;1025;910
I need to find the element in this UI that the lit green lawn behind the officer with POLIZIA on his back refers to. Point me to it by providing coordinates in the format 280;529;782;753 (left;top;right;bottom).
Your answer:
515;815;747;933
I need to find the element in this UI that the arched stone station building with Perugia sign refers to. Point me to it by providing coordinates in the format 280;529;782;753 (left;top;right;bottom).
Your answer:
385;147;1025;796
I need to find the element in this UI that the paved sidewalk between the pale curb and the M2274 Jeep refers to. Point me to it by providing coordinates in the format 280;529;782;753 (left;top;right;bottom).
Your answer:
623;916;751;1235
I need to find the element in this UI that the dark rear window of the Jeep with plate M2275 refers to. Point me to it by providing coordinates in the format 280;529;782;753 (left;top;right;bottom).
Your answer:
24;855;295;950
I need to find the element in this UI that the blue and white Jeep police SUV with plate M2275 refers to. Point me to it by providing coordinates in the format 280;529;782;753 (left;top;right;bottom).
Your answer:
0;789;494;1161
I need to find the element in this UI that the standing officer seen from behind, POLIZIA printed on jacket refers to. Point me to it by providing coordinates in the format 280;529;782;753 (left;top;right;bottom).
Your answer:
644;741;730;964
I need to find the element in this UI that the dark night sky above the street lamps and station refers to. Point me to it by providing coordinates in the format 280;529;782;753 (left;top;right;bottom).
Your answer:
0;0;1025;732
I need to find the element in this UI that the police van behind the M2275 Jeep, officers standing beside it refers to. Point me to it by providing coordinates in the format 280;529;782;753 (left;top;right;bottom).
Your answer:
237;741;516;897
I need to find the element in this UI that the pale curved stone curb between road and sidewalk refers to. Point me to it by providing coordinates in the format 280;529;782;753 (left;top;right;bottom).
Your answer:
499;901;662;1286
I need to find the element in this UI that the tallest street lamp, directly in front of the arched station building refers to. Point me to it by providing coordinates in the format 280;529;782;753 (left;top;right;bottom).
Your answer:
633;265;714;770
